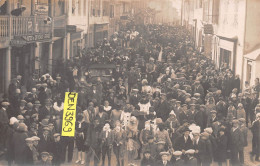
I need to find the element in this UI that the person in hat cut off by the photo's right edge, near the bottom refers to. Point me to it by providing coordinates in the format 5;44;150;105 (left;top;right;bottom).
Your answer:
250;113;260;161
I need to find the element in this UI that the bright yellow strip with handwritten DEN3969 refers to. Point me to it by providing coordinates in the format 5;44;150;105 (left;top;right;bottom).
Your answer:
61;92;78;137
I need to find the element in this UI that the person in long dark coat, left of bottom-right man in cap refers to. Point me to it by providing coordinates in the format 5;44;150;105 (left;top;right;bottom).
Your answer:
215;128;227;166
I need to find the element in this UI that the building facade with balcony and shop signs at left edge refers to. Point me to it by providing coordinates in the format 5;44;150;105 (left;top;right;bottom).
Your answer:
0;0;66;93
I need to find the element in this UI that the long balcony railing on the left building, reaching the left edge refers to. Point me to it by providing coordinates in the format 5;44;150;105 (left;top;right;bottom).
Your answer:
0;16;52;37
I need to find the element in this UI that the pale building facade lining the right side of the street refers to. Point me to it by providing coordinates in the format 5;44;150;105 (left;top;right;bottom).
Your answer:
181;0;260;88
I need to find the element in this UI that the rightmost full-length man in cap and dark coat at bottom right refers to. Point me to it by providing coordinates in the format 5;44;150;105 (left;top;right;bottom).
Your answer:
230;120;244;165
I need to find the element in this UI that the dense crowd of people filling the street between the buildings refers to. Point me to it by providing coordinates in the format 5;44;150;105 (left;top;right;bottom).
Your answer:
0;25;260;166
